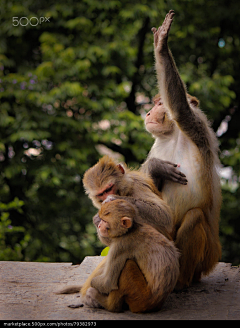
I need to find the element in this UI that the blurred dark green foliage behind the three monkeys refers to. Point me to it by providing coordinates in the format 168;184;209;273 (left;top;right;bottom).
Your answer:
0;0;240;265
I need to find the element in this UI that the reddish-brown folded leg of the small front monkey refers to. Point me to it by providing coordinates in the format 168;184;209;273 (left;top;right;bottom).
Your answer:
94;260;165;313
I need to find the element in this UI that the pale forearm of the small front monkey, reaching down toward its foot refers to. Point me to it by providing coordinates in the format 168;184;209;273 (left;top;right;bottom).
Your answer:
91;243;127;294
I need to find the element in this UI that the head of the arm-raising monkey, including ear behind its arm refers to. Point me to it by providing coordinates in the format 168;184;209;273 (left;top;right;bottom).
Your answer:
145;94;199;137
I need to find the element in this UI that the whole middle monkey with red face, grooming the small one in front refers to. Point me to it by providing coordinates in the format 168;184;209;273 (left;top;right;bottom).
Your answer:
58;156;177;298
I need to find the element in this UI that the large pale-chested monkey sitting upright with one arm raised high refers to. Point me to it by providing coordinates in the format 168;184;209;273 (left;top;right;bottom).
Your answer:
142;10;221;289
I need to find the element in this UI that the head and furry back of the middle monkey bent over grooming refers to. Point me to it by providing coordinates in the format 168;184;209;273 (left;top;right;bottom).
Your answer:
83;156;172;238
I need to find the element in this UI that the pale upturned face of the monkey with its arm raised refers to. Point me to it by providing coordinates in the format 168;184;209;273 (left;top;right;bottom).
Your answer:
145;97;174;137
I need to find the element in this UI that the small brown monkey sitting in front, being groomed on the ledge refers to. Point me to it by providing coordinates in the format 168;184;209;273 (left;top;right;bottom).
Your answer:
84;199;179;312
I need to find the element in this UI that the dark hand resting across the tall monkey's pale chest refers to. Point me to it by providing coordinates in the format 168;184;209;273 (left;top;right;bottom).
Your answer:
149;158;188;185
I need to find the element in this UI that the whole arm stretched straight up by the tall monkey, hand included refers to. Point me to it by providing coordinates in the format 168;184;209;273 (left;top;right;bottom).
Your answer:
152;10;209;150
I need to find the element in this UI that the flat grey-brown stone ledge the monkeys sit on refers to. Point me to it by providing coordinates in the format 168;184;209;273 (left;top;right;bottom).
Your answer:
0;256;240;320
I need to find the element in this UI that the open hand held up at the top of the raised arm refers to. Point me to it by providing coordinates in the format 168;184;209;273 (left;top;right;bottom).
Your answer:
152;10;175;52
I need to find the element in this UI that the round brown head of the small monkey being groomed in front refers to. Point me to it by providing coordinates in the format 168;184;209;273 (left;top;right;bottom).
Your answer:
98;199;136;239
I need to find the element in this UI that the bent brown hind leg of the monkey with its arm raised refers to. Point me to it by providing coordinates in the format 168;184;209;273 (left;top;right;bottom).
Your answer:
175;208;207;289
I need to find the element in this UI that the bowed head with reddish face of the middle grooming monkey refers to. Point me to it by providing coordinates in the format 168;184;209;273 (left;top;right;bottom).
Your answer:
83;156;132;208
